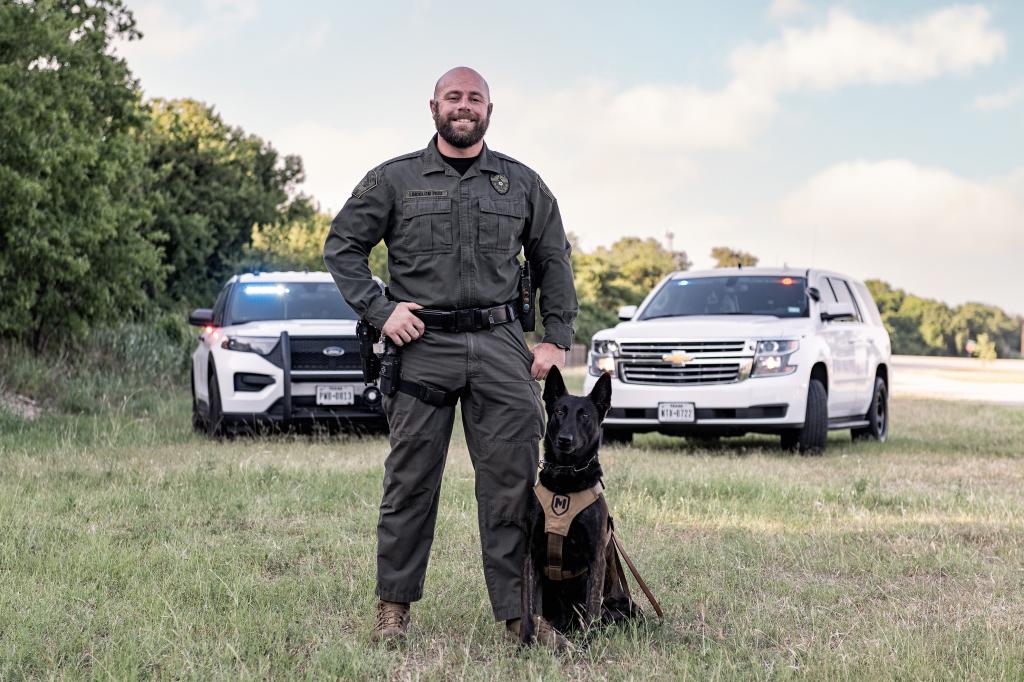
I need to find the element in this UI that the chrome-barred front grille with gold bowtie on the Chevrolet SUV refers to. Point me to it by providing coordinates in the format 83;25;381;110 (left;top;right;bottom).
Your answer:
618;341;754;385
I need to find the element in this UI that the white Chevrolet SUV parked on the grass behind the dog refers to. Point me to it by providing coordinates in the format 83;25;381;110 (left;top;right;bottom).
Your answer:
585;268;891;453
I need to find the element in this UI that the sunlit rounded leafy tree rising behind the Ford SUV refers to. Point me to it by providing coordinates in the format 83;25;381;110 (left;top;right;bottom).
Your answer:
144;99;305;301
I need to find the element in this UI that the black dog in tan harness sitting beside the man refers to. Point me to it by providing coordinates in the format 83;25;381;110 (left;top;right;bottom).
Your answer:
519;368;636;643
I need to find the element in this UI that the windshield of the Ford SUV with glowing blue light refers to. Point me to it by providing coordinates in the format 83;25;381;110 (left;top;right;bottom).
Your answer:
225;282;358;325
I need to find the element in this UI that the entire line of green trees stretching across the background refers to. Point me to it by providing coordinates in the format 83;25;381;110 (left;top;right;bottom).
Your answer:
0;0;1022;356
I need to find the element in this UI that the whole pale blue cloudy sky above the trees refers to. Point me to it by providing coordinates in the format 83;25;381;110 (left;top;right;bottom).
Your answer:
117;0;1024;313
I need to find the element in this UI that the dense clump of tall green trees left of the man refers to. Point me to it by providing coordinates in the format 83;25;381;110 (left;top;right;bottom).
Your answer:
0;0;305;348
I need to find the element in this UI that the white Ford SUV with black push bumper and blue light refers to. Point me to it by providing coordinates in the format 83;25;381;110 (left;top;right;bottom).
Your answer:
188;272;387;436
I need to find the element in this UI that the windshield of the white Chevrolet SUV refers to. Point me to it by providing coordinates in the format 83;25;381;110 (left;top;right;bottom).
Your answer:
638;275;807;319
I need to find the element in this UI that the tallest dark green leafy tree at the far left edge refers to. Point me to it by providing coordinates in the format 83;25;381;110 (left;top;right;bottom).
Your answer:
0;0;163;347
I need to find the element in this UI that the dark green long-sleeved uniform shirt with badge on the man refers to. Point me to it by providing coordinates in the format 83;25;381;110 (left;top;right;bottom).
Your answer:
324;137;578;347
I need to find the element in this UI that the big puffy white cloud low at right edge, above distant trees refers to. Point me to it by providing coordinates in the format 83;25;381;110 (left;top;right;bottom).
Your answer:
778;160;1024;312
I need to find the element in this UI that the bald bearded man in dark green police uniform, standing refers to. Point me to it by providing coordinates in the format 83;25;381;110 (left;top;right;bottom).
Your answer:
324;67;577;648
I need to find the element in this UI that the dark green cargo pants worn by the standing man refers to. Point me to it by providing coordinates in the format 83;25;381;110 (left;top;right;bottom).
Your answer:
377;323;544;621
